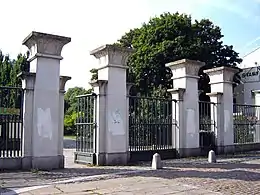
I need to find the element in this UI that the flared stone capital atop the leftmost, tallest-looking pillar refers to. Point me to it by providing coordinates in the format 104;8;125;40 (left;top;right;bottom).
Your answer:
22;31;71;61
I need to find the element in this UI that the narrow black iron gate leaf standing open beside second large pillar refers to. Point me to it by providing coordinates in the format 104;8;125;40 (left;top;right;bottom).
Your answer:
75;94;97;164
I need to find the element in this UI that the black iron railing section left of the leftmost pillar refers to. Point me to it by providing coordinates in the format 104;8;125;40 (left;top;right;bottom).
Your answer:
0;86;23;158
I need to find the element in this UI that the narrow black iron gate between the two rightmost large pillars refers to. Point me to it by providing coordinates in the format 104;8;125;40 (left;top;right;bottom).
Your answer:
199;101;218;155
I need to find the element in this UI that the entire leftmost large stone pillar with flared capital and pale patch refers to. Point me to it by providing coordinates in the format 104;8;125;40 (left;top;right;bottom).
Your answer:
23;32;71;169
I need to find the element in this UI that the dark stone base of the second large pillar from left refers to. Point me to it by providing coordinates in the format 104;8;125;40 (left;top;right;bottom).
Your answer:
96;152;129;166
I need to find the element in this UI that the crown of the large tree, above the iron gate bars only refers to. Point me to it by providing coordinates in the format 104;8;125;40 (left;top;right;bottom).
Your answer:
112;13;242;95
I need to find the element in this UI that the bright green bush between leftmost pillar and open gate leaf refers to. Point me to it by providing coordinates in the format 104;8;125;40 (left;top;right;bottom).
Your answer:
64;87;93;135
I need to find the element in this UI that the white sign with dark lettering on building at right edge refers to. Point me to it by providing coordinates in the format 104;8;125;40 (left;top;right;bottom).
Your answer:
239;67;260;83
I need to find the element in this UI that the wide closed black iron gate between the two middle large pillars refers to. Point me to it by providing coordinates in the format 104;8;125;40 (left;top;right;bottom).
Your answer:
129;96;177;161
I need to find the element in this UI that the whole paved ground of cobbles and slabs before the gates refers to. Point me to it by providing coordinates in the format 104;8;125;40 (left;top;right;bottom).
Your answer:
0;139;260;195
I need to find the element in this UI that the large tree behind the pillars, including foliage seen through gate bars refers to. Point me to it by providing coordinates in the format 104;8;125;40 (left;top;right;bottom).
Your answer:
87;13;242;149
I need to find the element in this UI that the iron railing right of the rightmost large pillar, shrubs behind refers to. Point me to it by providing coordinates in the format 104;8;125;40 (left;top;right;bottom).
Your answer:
233;104;260;144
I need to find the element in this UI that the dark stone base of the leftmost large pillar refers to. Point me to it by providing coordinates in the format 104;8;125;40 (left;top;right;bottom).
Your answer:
32;155;64;170
